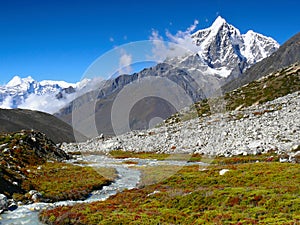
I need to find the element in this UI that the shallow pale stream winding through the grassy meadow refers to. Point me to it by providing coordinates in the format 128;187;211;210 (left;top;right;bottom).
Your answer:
0;155;205;225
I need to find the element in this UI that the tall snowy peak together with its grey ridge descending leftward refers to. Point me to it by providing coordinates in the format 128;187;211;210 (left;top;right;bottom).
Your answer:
55;17;279;137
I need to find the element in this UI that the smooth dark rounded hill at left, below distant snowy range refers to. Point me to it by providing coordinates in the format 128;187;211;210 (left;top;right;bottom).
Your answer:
0;109;86;143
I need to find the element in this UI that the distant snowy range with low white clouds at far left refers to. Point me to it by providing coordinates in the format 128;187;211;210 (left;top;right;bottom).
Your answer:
0;76;88;113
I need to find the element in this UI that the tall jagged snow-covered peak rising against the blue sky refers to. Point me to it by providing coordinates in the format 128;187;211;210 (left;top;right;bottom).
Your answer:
191;16;279;77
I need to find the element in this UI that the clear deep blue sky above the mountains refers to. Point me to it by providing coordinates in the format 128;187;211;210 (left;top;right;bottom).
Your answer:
0;0;300;85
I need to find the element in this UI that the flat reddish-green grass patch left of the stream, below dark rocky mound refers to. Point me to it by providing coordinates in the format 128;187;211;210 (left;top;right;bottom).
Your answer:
17;162;116;202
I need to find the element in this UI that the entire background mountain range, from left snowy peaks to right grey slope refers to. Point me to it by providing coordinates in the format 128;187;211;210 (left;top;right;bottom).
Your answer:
0;17;299;138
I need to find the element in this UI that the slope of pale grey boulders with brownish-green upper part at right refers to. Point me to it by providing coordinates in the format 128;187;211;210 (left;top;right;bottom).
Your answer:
63;65;300;162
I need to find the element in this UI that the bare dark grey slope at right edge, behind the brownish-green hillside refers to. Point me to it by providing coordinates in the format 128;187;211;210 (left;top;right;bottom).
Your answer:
222;33;300;92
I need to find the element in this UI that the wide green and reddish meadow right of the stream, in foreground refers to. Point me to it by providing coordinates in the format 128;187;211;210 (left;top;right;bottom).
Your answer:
40;156;300;225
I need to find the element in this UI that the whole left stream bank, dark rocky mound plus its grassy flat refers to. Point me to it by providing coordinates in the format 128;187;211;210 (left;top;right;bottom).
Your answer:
0;131;116;203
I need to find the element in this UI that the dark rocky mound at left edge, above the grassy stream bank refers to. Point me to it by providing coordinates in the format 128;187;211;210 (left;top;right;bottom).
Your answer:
0;131;69;198
